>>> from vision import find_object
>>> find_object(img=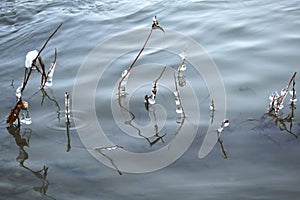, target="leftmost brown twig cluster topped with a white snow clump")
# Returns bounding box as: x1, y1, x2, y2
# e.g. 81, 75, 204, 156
6, 23, 62, 126
